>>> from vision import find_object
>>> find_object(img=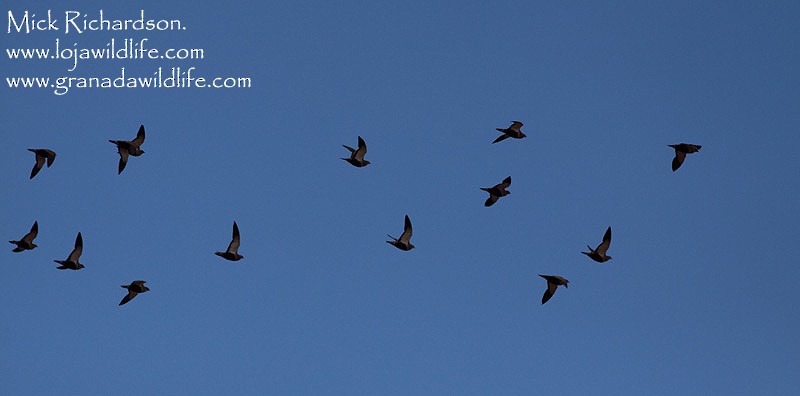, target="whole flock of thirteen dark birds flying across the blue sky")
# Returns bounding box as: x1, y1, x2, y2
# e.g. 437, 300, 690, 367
9, 121, 702, 305
